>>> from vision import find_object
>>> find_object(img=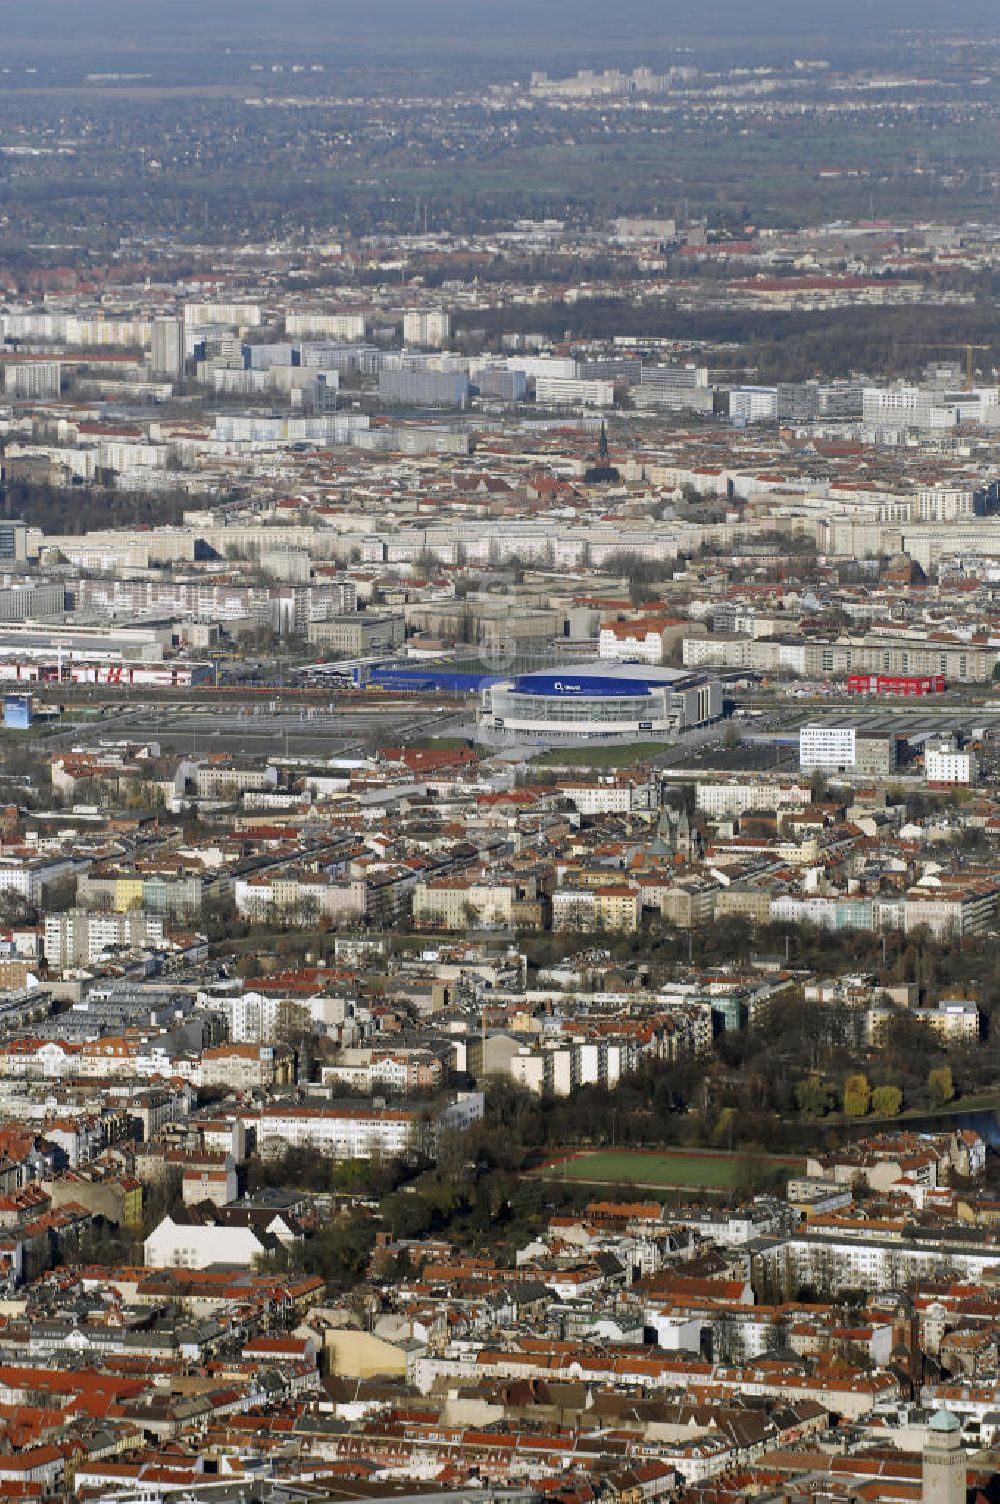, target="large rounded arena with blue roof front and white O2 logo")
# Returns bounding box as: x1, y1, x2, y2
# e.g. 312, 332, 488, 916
477, 660, 722, 743
